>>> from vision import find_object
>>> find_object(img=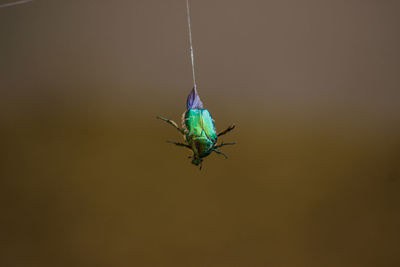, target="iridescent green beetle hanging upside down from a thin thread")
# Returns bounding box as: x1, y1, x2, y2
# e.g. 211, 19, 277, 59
157, 86, 235, 170
